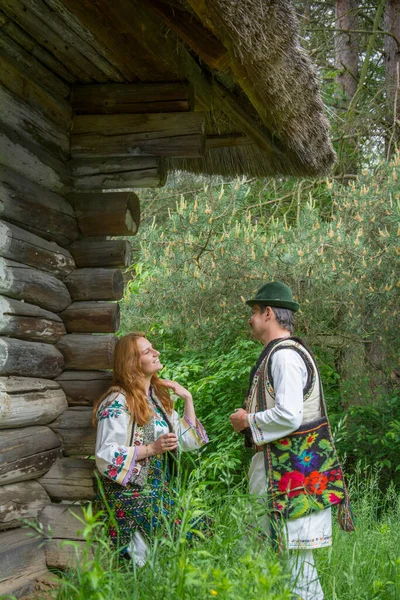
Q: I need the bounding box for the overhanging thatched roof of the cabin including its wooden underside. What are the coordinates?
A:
[0,0,334,176]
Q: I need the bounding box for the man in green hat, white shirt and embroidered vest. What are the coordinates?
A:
[230,281,332,600]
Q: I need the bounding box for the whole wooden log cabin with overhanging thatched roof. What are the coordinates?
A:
[0,0,334,597]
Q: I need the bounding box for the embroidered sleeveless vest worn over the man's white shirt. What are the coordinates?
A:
[246,338,321,425]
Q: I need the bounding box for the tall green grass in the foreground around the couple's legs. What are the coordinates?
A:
[50,469,400,600]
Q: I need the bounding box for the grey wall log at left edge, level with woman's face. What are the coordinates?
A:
[0,336,64,379]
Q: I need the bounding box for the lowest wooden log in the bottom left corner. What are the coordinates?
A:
[0,528,48,599]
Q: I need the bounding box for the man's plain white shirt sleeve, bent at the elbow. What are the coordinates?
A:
[248,348,307,446]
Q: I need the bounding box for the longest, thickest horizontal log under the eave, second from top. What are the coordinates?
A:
[71,112,205,158]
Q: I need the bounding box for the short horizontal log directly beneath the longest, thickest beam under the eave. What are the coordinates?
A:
[69,156,167,192]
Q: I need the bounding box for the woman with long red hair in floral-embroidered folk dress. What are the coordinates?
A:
[93,333,208,566]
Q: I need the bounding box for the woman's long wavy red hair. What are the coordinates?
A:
[92,333,172,425]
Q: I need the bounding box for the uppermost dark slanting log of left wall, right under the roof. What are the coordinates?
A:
[0,29,69,98]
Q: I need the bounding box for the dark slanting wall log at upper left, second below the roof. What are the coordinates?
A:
[0,55,72,129]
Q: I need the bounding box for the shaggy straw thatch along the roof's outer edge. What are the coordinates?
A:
[170,0,335,175]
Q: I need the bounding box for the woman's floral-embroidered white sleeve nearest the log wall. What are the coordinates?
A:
[95,394,141,486]
